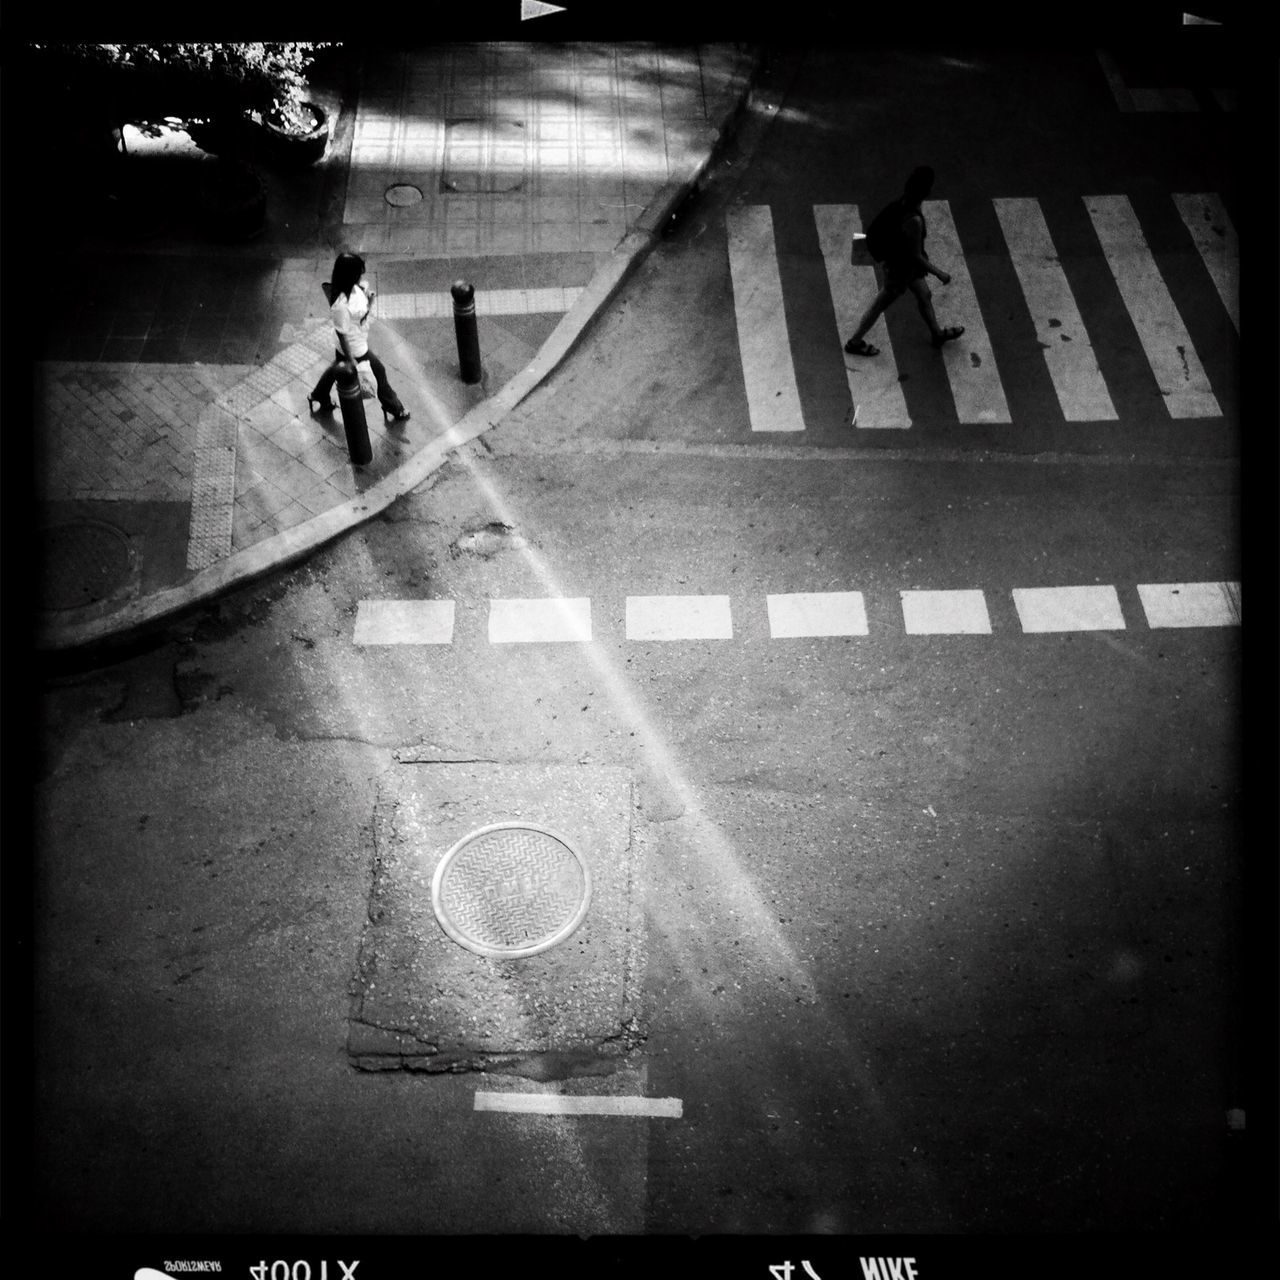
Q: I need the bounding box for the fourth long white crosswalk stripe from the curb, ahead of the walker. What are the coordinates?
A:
[995,198,1119,422]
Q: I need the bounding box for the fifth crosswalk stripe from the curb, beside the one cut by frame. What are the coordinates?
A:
[1084,196,1222,417]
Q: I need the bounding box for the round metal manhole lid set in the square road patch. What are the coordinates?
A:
[431,822,591,959]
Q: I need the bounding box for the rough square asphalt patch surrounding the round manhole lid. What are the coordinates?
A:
[347,763,643,1078]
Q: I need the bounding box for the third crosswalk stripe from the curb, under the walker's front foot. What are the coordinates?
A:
[924,200,1010,422]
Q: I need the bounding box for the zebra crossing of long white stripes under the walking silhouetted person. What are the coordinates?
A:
[726,192,1239,433]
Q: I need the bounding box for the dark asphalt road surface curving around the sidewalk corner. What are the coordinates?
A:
[24,32,1244,1261]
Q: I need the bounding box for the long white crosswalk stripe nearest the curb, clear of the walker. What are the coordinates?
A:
[726,205,804,431]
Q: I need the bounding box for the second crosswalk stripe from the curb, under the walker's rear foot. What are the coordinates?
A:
[813,205,911,429]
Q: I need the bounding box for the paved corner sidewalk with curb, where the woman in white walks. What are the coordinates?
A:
[35,44,755,650]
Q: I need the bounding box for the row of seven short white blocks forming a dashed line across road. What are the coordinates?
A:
[352,582,1240,648]
